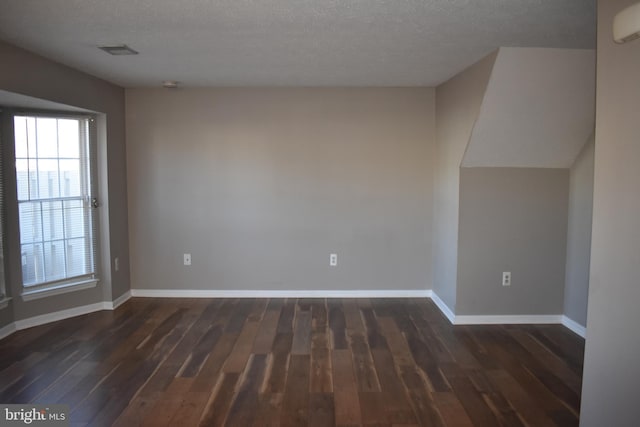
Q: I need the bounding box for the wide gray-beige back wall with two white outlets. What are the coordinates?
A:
[126,88,435,290]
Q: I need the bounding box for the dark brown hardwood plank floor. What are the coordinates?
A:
[0,298,584,427]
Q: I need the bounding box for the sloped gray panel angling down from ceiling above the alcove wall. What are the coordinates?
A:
[462,48,595,168]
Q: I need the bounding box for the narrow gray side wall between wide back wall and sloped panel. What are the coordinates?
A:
[433,51,498,310]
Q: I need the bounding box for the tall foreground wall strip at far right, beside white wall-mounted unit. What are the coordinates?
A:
[580,0,640,427]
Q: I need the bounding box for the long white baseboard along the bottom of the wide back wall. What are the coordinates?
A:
[131,289,432,298]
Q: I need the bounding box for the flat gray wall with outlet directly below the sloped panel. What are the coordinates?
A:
[456,168,569,315]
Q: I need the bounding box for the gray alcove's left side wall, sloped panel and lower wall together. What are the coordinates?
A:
[434,48,595,321]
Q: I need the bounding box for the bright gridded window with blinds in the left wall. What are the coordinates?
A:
[13,115,98,291]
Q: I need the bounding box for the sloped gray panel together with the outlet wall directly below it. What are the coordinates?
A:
[456,48,595,321]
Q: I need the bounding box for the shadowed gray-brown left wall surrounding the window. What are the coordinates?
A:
[0,42,129,320]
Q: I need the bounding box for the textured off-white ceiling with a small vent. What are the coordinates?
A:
[0,0,596,87]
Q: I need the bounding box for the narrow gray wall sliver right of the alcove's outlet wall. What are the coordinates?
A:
[564,136,594,326]
